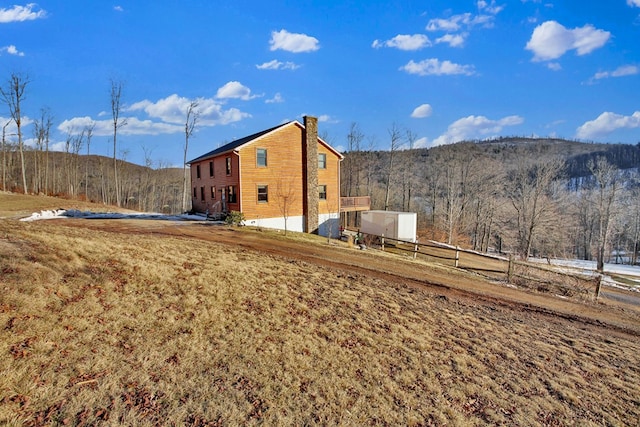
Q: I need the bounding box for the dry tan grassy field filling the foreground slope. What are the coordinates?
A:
[0,196,640,426]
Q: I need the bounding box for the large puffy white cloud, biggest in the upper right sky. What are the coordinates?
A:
[525,21,611,61]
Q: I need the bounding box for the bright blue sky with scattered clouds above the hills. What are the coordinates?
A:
[0,0,640,165]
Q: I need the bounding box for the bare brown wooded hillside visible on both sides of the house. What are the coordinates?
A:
[0,132,640,264]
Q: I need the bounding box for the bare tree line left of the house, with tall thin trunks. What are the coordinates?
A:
[0,73,190,213]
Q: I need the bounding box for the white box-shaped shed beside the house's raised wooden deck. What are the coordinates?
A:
[360,211,418,242]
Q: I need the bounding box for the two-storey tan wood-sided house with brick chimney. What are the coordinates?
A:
[189,116,343,235]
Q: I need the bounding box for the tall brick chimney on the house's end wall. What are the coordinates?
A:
[302,116,320,234]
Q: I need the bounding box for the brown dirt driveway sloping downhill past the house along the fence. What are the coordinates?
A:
[57,219,640,335]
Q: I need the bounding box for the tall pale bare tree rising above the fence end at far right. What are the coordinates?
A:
[587,157,619,273]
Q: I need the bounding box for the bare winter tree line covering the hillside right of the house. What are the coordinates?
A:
[341,124,640,269]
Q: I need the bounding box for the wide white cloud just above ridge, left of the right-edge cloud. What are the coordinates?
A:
[431,116,524,146]
